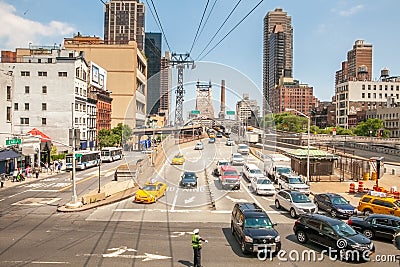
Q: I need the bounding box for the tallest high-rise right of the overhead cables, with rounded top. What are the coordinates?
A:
[263,8,293,111]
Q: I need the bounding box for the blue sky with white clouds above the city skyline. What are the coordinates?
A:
[0,0,400,105]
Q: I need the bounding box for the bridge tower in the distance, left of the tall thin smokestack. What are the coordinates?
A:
[196,82,215,119]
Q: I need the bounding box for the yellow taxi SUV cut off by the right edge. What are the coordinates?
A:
[357,194,400,216]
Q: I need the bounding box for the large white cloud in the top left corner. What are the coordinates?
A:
[0,1,76,50]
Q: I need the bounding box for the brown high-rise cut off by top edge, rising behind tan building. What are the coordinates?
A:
[104,0,145,50]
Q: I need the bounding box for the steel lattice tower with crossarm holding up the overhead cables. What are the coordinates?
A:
[169,53,195,125]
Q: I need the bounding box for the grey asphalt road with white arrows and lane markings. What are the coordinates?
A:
[0,142,400,267]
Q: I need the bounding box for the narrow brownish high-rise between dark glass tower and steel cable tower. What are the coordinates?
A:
[158,52,171,124]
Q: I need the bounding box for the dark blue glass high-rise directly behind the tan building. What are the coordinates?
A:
[144,32,161,114]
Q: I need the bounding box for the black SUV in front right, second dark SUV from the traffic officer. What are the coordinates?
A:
[293,214,375,261]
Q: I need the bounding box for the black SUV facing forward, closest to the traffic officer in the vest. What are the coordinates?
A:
[231,202,281,254]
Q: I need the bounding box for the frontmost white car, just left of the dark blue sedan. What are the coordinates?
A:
[275,189,318,218]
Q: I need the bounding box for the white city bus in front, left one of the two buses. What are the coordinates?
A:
[65,150,100,171]
